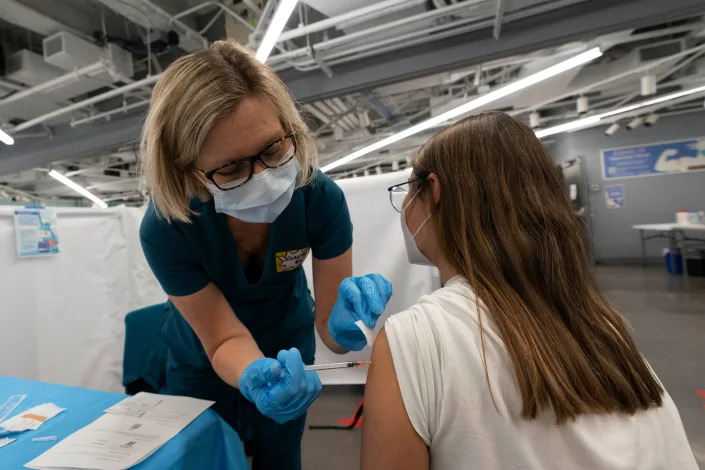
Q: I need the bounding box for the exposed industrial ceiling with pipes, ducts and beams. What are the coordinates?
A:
[0,0,705,204]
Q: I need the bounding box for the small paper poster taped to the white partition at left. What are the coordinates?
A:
[15,207,59,258]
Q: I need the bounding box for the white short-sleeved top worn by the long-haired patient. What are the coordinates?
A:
[385,276,698,470]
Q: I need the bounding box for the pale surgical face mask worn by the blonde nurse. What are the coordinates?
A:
[204,149,301,224]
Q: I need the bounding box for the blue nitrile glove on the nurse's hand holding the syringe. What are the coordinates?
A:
[238,348,321,424]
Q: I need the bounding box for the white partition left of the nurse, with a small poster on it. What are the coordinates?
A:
[0,207,165,391]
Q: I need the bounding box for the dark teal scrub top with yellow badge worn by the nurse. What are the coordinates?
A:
[140,171,352,368]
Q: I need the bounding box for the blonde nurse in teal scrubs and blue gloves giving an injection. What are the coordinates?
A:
[140,41,392,469]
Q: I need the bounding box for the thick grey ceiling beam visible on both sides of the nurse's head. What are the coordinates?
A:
[0,0,703,175]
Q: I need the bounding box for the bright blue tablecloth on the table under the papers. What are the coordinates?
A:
[0,376,249,470]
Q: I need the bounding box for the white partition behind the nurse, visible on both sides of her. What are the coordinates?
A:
[0,172,438,391]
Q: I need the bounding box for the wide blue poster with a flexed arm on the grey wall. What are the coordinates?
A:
[601,137,705,180]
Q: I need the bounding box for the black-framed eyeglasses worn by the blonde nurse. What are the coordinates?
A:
[194,132,296,191]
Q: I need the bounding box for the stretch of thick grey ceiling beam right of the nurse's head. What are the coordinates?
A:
[280,0,703,102]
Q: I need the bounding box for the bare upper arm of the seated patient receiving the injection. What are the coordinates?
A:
[361,328,429,470]
